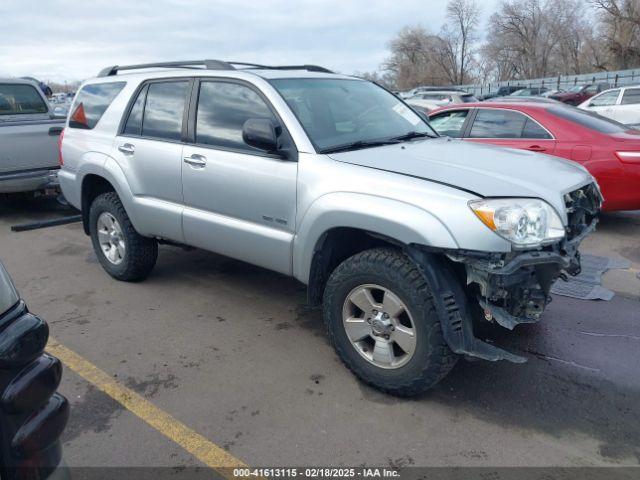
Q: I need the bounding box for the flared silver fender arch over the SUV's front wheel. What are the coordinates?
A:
[293,192,458,284]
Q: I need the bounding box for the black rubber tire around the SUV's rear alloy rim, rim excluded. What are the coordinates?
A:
[89,192,158,282]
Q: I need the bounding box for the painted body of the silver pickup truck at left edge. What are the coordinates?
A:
[0,79,65,193]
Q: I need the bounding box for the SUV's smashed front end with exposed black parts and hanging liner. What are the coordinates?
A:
[412,184,602,363]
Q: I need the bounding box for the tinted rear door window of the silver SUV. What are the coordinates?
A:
[141,80,189,140]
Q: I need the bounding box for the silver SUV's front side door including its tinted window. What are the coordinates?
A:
[182,79,298,274]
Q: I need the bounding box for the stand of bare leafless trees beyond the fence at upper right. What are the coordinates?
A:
[372,0,640,89]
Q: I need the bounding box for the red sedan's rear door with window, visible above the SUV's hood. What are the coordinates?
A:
[467,108,556,153]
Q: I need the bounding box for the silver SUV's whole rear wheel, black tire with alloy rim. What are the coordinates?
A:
[89,192,158,282]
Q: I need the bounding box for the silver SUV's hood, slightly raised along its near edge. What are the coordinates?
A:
[330,137,593,216]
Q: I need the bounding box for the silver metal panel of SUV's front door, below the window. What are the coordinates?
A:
[181,145,298,275]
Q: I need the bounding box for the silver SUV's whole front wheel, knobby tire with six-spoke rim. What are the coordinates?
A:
[324,248,458,396]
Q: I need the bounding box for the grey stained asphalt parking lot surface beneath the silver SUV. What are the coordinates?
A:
[0,195,640,468]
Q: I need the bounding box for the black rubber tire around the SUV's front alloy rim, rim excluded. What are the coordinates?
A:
[323,248,458,397]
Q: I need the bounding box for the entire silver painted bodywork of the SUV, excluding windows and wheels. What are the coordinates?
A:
[60,70,593,283]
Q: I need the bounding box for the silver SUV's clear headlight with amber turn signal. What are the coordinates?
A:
[469,198,565,248]
